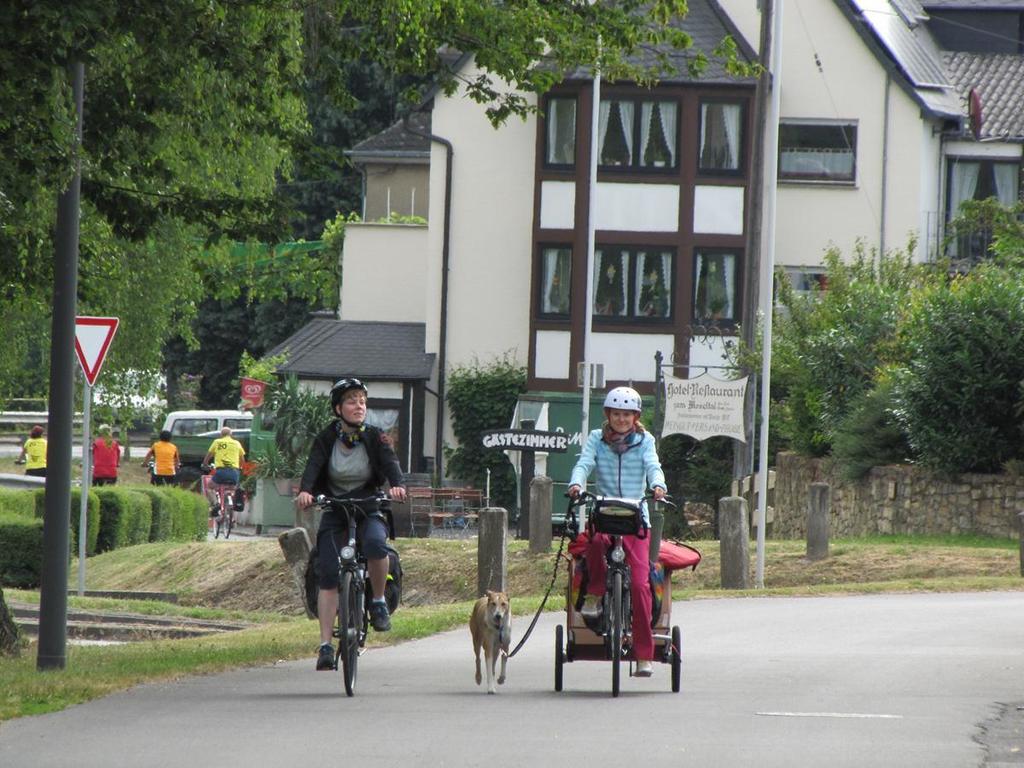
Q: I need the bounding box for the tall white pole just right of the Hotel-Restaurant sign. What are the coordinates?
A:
[755,0,782,589]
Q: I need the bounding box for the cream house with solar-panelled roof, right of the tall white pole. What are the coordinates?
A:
[722,0,1024,287]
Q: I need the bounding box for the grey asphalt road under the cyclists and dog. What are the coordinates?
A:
[0,593,1024,768]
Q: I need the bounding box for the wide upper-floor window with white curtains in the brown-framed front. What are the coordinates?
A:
[598,99,679,168]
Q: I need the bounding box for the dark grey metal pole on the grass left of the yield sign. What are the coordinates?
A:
[36,61,85,671]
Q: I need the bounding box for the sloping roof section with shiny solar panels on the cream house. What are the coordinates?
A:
[836,0,965,120]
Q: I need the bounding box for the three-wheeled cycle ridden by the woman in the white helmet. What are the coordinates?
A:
[555,492,700,696]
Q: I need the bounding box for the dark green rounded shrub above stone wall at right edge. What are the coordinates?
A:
[896,265,1024,473]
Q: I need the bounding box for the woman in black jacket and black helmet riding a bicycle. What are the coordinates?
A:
[295,378,406,670]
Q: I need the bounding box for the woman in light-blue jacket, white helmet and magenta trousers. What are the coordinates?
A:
[568,387,667,677]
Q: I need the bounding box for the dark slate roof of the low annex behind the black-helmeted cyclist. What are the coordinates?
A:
[267,317,434,381]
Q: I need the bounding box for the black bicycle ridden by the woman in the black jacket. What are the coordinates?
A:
[316,494,388,696]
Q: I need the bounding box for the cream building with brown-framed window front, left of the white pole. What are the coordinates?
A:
[331,0,755,481]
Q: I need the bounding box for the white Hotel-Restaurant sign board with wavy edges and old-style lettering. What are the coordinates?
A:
[662,374,748,442]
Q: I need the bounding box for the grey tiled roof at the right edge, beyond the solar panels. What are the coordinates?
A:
[943,51,1024,138]
